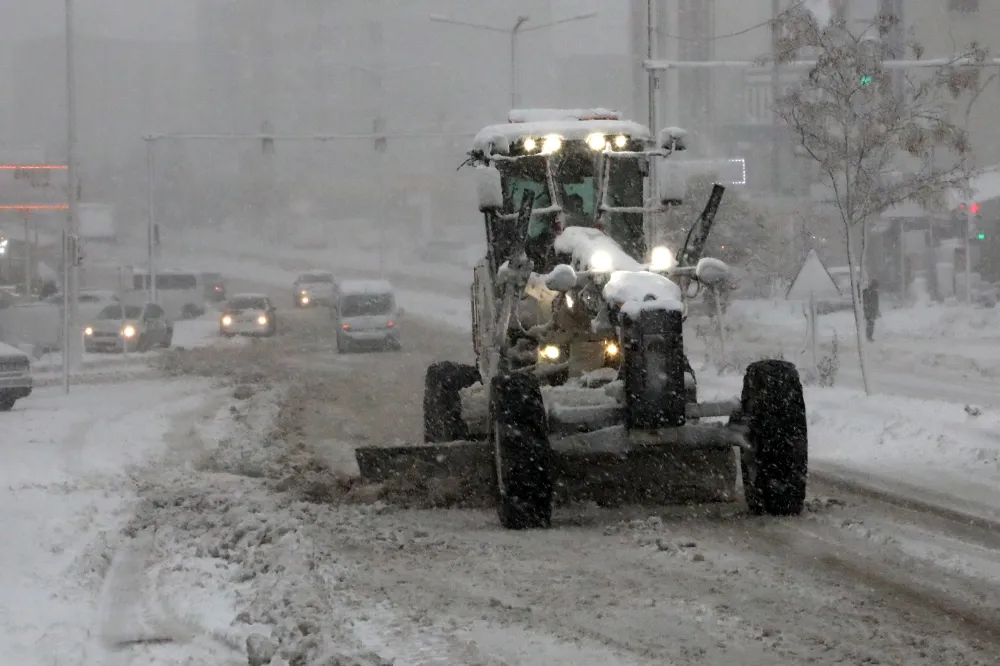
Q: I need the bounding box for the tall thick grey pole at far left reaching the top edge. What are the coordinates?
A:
[62,0,82,393]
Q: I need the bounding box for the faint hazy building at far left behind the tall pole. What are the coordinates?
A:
[8,34,197,223]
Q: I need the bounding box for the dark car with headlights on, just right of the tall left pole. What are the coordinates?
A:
[83,303,174,353]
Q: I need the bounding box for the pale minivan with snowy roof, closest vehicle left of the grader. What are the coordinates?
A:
[330,280,403,353]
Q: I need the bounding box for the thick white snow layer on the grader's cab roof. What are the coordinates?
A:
[473,109,653,151]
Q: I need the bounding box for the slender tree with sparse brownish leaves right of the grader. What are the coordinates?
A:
[772,4,987,394]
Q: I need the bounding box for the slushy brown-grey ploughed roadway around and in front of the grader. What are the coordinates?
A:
[113,300,1000,666]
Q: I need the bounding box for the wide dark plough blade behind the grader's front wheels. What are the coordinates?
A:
[355,428,737,507]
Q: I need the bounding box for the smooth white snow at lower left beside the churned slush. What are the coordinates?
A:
[0,380,229,666]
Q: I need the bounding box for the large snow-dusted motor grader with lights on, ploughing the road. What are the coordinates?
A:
[357,109,808,529]
